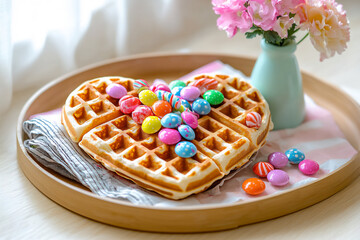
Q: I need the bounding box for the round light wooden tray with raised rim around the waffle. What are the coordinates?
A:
[17,54,360,232]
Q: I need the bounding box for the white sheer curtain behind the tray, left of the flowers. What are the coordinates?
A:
[0,0,216,113]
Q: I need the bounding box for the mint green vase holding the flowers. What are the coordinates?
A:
[251,39,305,130]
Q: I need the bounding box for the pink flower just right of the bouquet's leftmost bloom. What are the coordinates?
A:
[247,0,278,31]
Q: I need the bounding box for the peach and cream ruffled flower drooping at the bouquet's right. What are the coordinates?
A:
[302,0,350,61]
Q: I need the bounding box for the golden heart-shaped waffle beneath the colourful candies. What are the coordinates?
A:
[62,75,272,199]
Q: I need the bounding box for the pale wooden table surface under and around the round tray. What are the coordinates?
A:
[0,0,360,240]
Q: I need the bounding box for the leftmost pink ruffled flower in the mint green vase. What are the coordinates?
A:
[212,0,253,38]
